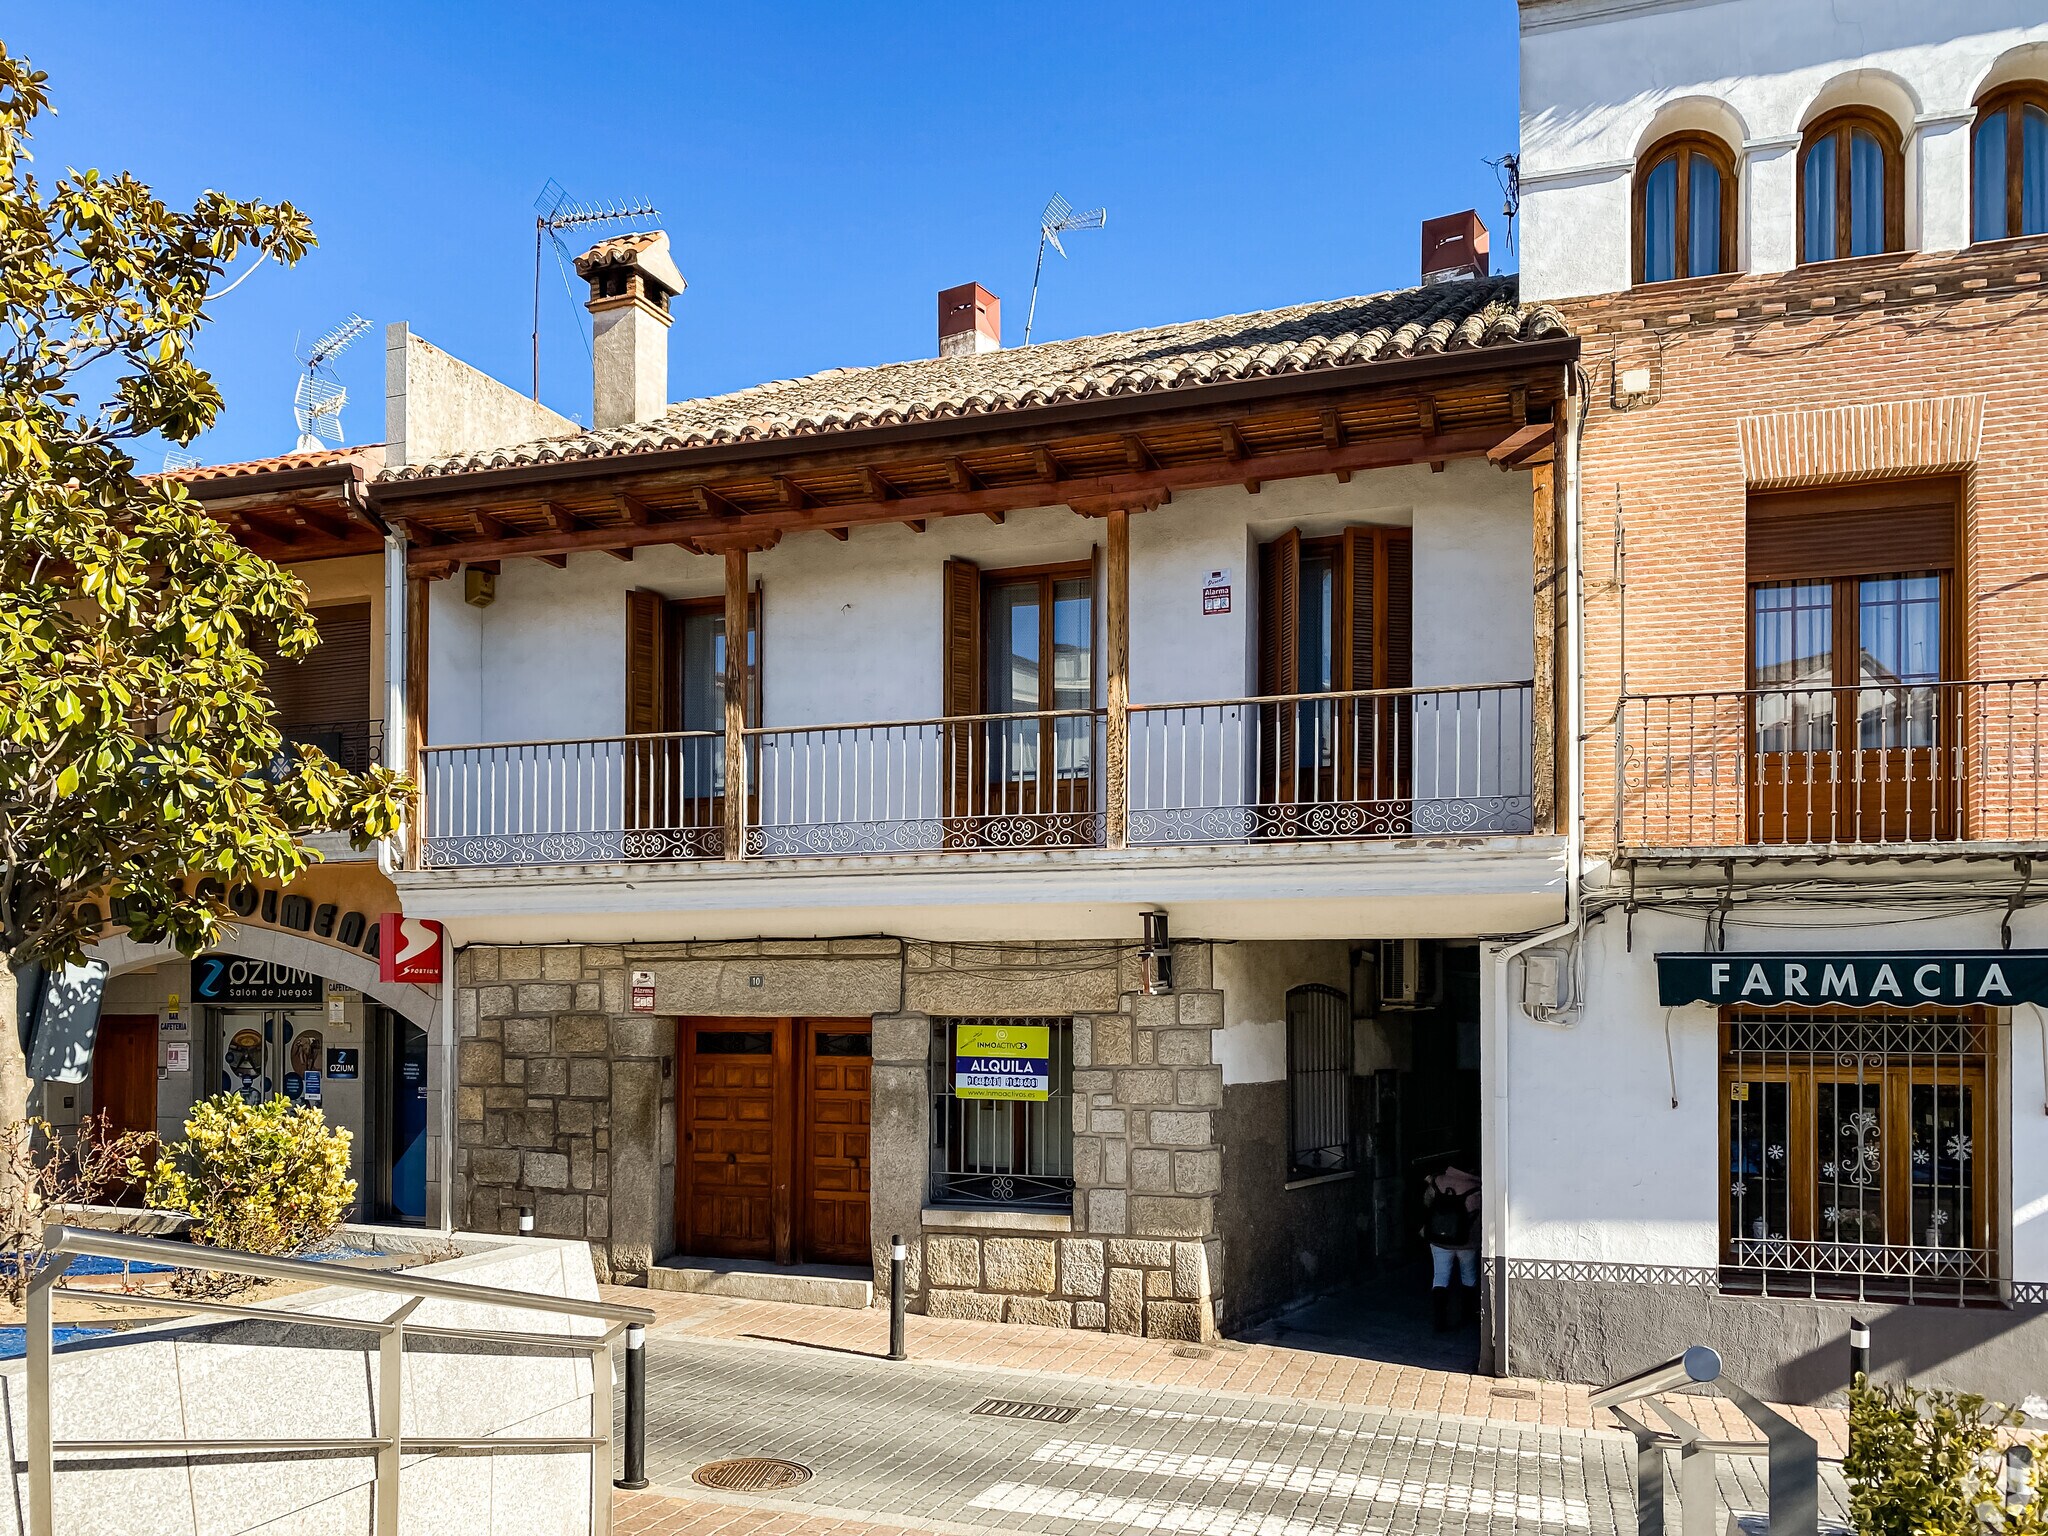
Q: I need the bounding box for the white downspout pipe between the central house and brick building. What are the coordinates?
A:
[1481,365,1587,1376]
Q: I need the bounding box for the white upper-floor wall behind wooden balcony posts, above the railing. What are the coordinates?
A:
[428,463,1534,743]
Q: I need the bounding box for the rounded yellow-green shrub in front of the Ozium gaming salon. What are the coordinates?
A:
[131,1094,356,1253]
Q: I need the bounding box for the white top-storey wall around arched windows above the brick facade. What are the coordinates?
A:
[1522,0,2048,299]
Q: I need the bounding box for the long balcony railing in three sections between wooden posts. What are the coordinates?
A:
[420,682,1532,868]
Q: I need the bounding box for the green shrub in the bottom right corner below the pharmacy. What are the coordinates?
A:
[1841,1376,2048,1536]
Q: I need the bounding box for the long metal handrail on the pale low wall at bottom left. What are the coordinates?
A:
[25,1225,653,1536]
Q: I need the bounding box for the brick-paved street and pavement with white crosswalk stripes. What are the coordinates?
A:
[598,1290,1841,1536]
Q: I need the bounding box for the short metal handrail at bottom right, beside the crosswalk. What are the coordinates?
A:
[1591,1343,1821,1536]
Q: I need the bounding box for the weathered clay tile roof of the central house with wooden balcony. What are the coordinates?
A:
[383,276,1569,479]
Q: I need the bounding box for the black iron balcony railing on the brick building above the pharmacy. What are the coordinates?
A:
[1614,678,2048,850]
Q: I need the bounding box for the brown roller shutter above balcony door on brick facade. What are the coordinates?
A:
[1747,479,1960,582]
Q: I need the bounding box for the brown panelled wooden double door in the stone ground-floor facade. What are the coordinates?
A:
[676,1018,874,1264]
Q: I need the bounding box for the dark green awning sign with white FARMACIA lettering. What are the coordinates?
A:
[1657,950,2048,1008]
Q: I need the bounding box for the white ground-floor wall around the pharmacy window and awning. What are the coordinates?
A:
[1490,903,2048,1280]
